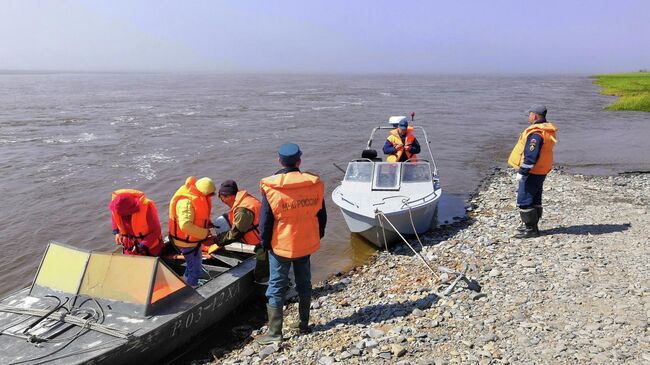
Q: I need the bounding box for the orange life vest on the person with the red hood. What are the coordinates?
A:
[111,189,163,256]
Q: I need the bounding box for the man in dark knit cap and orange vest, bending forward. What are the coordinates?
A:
[214,180,269,284]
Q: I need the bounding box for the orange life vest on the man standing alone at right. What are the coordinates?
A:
[508,122,557,175]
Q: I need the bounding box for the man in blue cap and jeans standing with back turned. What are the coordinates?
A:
[257,143,327,344]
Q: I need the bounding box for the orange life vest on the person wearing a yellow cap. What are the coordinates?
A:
[169,176,212,248]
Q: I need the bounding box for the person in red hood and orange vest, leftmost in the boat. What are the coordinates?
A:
[108,189,163,256]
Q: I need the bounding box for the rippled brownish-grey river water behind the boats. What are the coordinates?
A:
[0,73,650,294]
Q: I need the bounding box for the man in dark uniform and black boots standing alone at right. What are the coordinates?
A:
[508,105,557,238]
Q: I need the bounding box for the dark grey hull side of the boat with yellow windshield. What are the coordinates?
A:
[0,257,255,364]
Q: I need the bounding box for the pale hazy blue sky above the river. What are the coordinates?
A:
[0,0,650,73]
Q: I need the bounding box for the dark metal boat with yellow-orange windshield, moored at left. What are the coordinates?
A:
[0,242,255,364]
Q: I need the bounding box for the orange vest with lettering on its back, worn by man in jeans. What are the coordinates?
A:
[260,171,325,258]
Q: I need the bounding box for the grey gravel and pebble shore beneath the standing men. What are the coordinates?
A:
[214,170,650,365]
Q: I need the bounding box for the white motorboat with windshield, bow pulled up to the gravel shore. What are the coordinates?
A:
[332,117,442,248]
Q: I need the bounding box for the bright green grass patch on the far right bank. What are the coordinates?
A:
[594,72,650,112]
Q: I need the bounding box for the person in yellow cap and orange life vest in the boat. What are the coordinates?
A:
[169,176,216,286]
